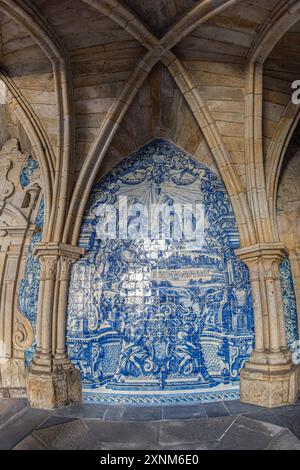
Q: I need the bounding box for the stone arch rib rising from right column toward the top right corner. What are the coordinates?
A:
[246,0,300,242]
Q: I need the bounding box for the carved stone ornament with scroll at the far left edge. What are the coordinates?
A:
[0,139,43,392]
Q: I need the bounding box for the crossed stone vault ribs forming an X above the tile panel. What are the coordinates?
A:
[64,0,256,245]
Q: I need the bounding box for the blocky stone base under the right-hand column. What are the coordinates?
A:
[241,362,299,408]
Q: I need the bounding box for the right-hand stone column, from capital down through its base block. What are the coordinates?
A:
[236,243,298,408]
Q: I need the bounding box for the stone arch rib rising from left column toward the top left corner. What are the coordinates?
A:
[0,0,74,241]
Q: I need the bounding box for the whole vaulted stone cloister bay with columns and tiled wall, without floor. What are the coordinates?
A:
[0,0,300,450]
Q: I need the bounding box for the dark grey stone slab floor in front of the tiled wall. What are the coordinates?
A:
[0,399,300,450]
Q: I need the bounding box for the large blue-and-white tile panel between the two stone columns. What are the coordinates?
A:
[67,139,254,404]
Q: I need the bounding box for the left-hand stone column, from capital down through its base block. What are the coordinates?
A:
[27,243,83,408]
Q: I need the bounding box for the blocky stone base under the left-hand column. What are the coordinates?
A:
[27,364,82,409]
